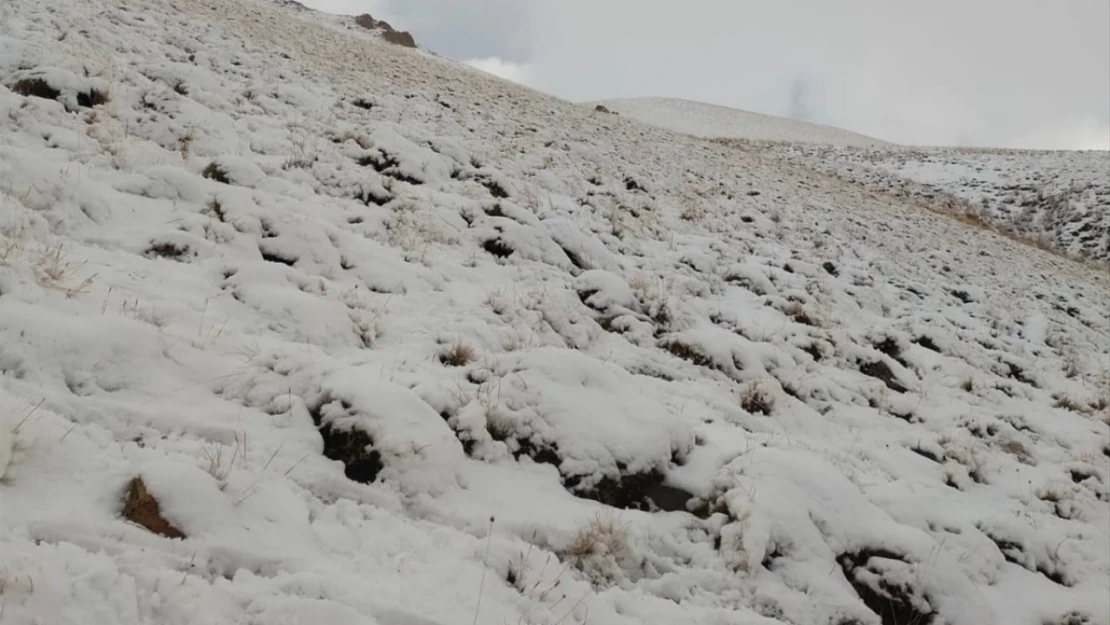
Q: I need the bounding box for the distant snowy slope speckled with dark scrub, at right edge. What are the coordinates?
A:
[754,143,1110,263]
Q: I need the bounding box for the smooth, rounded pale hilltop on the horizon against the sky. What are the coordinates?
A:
[588,98,888,148]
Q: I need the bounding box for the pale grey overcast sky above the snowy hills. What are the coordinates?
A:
[302,0,1110,150]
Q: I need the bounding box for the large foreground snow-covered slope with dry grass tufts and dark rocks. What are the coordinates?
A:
[0,0,1110,625]
